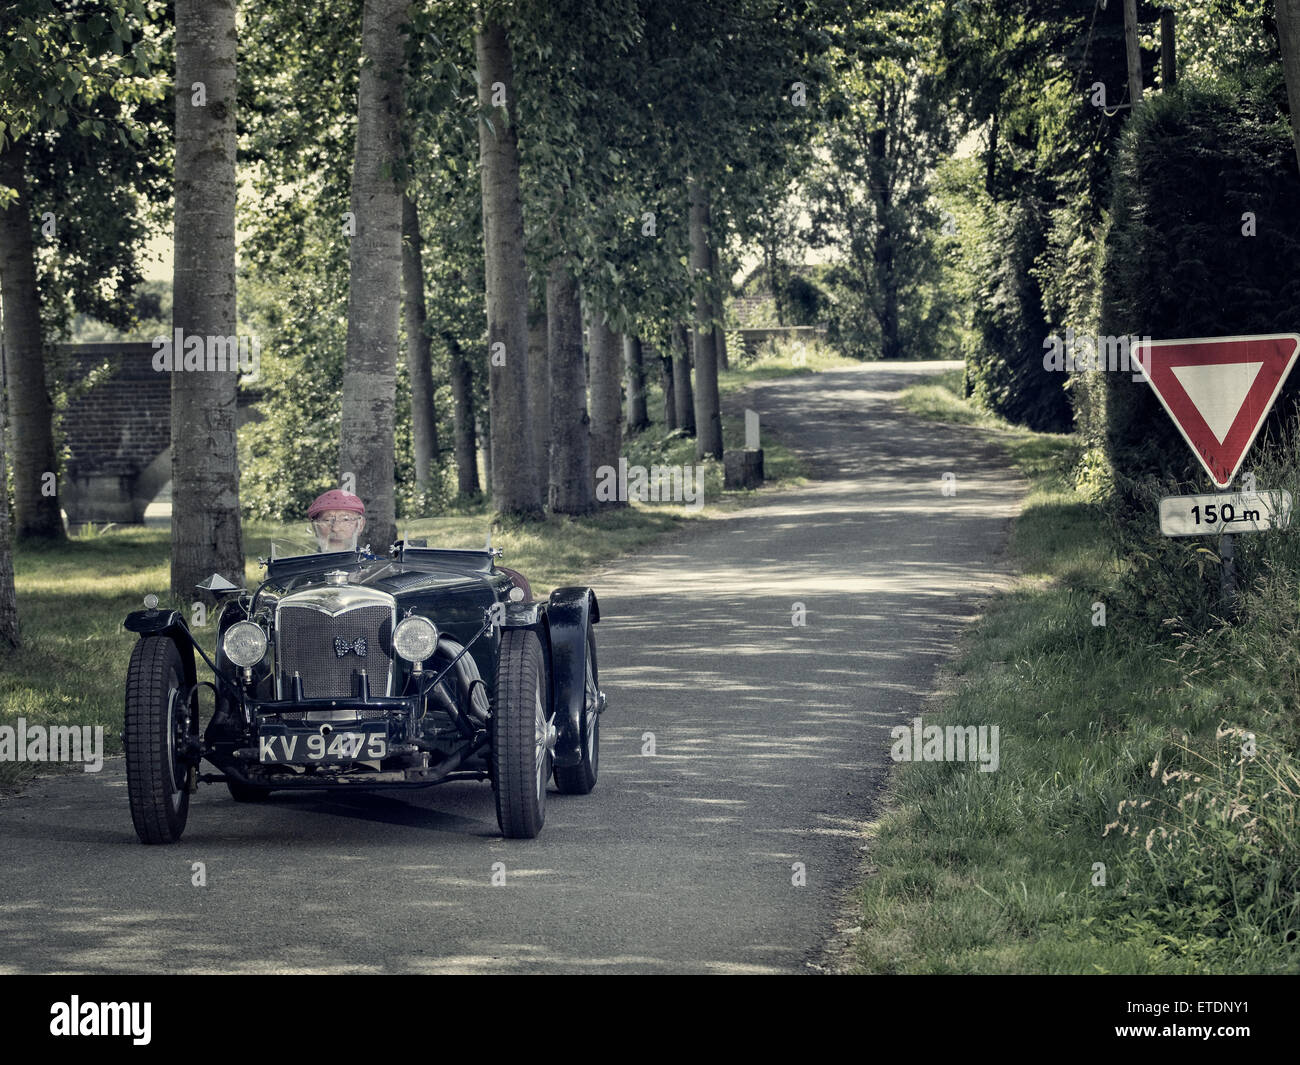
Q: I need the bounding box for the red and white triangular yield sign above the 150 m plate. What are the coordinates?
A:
[1138,333,1300,488]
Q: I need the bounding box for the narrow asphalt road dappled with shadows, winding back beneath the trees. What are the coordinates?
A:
[0,363,1023,973]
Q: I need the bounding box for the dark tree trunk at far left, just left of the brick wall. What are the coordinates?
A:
[0,142,64,541]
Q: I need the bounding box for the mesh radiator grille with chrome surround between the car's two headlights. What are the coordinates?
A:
[276,602,395,698]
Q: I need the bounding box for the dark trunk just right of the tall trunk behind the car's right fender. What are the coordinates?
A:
[546,259,594,514]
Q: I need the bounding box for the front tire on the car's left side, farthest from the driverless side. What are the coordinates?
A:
[124,636,198,844]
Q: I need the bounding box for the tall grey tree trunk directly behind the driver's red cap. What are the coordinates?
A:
[339,0,408,554]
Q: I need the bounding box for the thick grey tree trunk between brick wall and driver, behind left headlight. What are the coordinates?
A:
[172,0,244,602]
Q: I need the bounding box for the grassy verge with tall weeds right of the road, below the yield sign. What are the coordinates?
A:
[855,375,1300,973]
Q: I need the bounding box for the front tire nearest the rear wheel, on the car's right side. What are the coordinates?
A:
[491,629,551,840]
